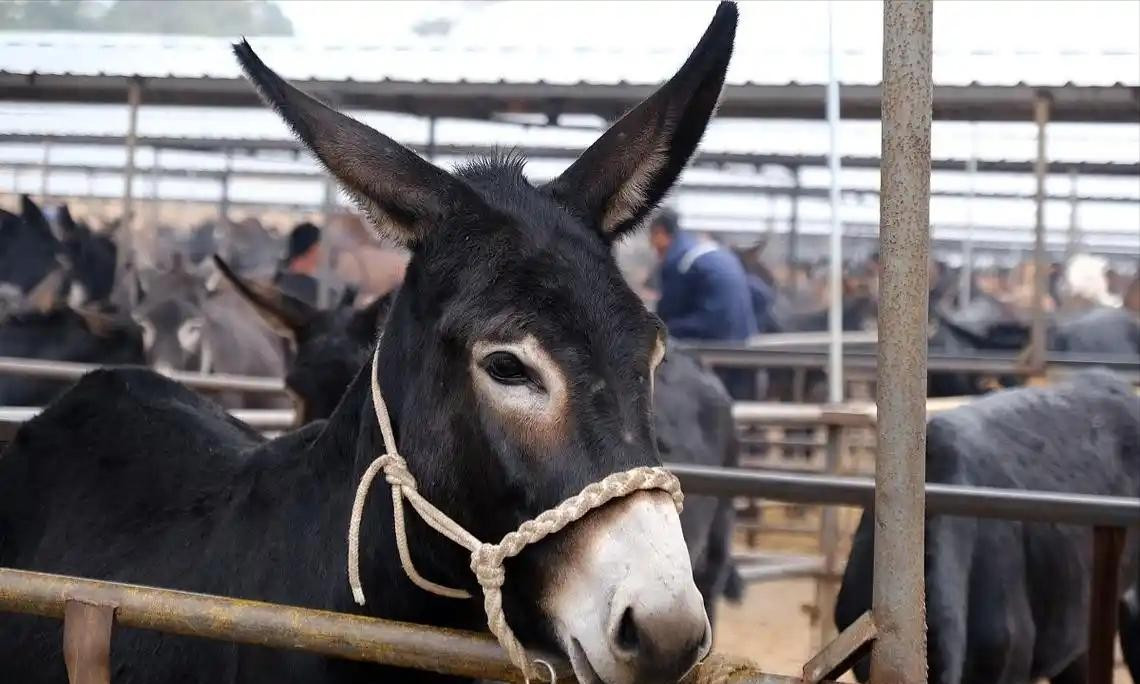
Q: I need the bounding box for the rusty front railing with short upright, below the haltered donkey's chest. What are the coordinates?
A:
[0,568,848,684]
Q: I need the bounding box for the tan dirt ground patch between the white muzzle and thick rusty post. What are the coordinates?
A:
[714,579,1140,684]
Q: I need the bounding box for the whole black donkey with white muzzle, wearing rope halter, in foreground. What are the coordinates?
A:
[0,3,736,684]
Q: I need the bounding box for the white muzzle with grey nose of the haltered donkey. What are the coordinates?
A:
[545,491,711,684]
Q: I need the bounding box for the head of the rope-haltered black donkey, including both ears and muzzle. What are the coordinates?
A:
[236,3,736,684]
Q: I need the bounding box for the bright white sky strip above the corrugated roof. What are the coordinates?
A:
[280,0,1140,52]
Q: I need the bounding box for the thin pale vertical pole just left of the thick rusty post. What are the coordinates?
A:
[828,2,844,404]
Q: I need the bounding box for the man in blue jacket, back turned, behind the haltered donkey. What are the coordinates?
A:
[650,209,757,399]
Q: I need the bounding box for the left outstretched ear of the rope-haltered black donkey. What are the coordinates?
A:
[234,41,480,245]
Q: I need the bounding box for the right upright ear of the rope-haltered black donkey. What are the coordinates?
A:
[548,2,736,238]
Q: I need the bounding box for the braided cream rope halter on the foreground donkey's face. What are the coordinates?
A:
[349,347,684,682]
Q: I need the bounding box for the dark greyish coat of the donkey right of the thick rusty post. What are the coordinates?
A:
[836,372,1140,684]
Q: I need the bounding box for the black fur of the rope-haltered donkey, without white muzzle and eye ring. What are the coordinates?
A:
[0,3,736,684]
